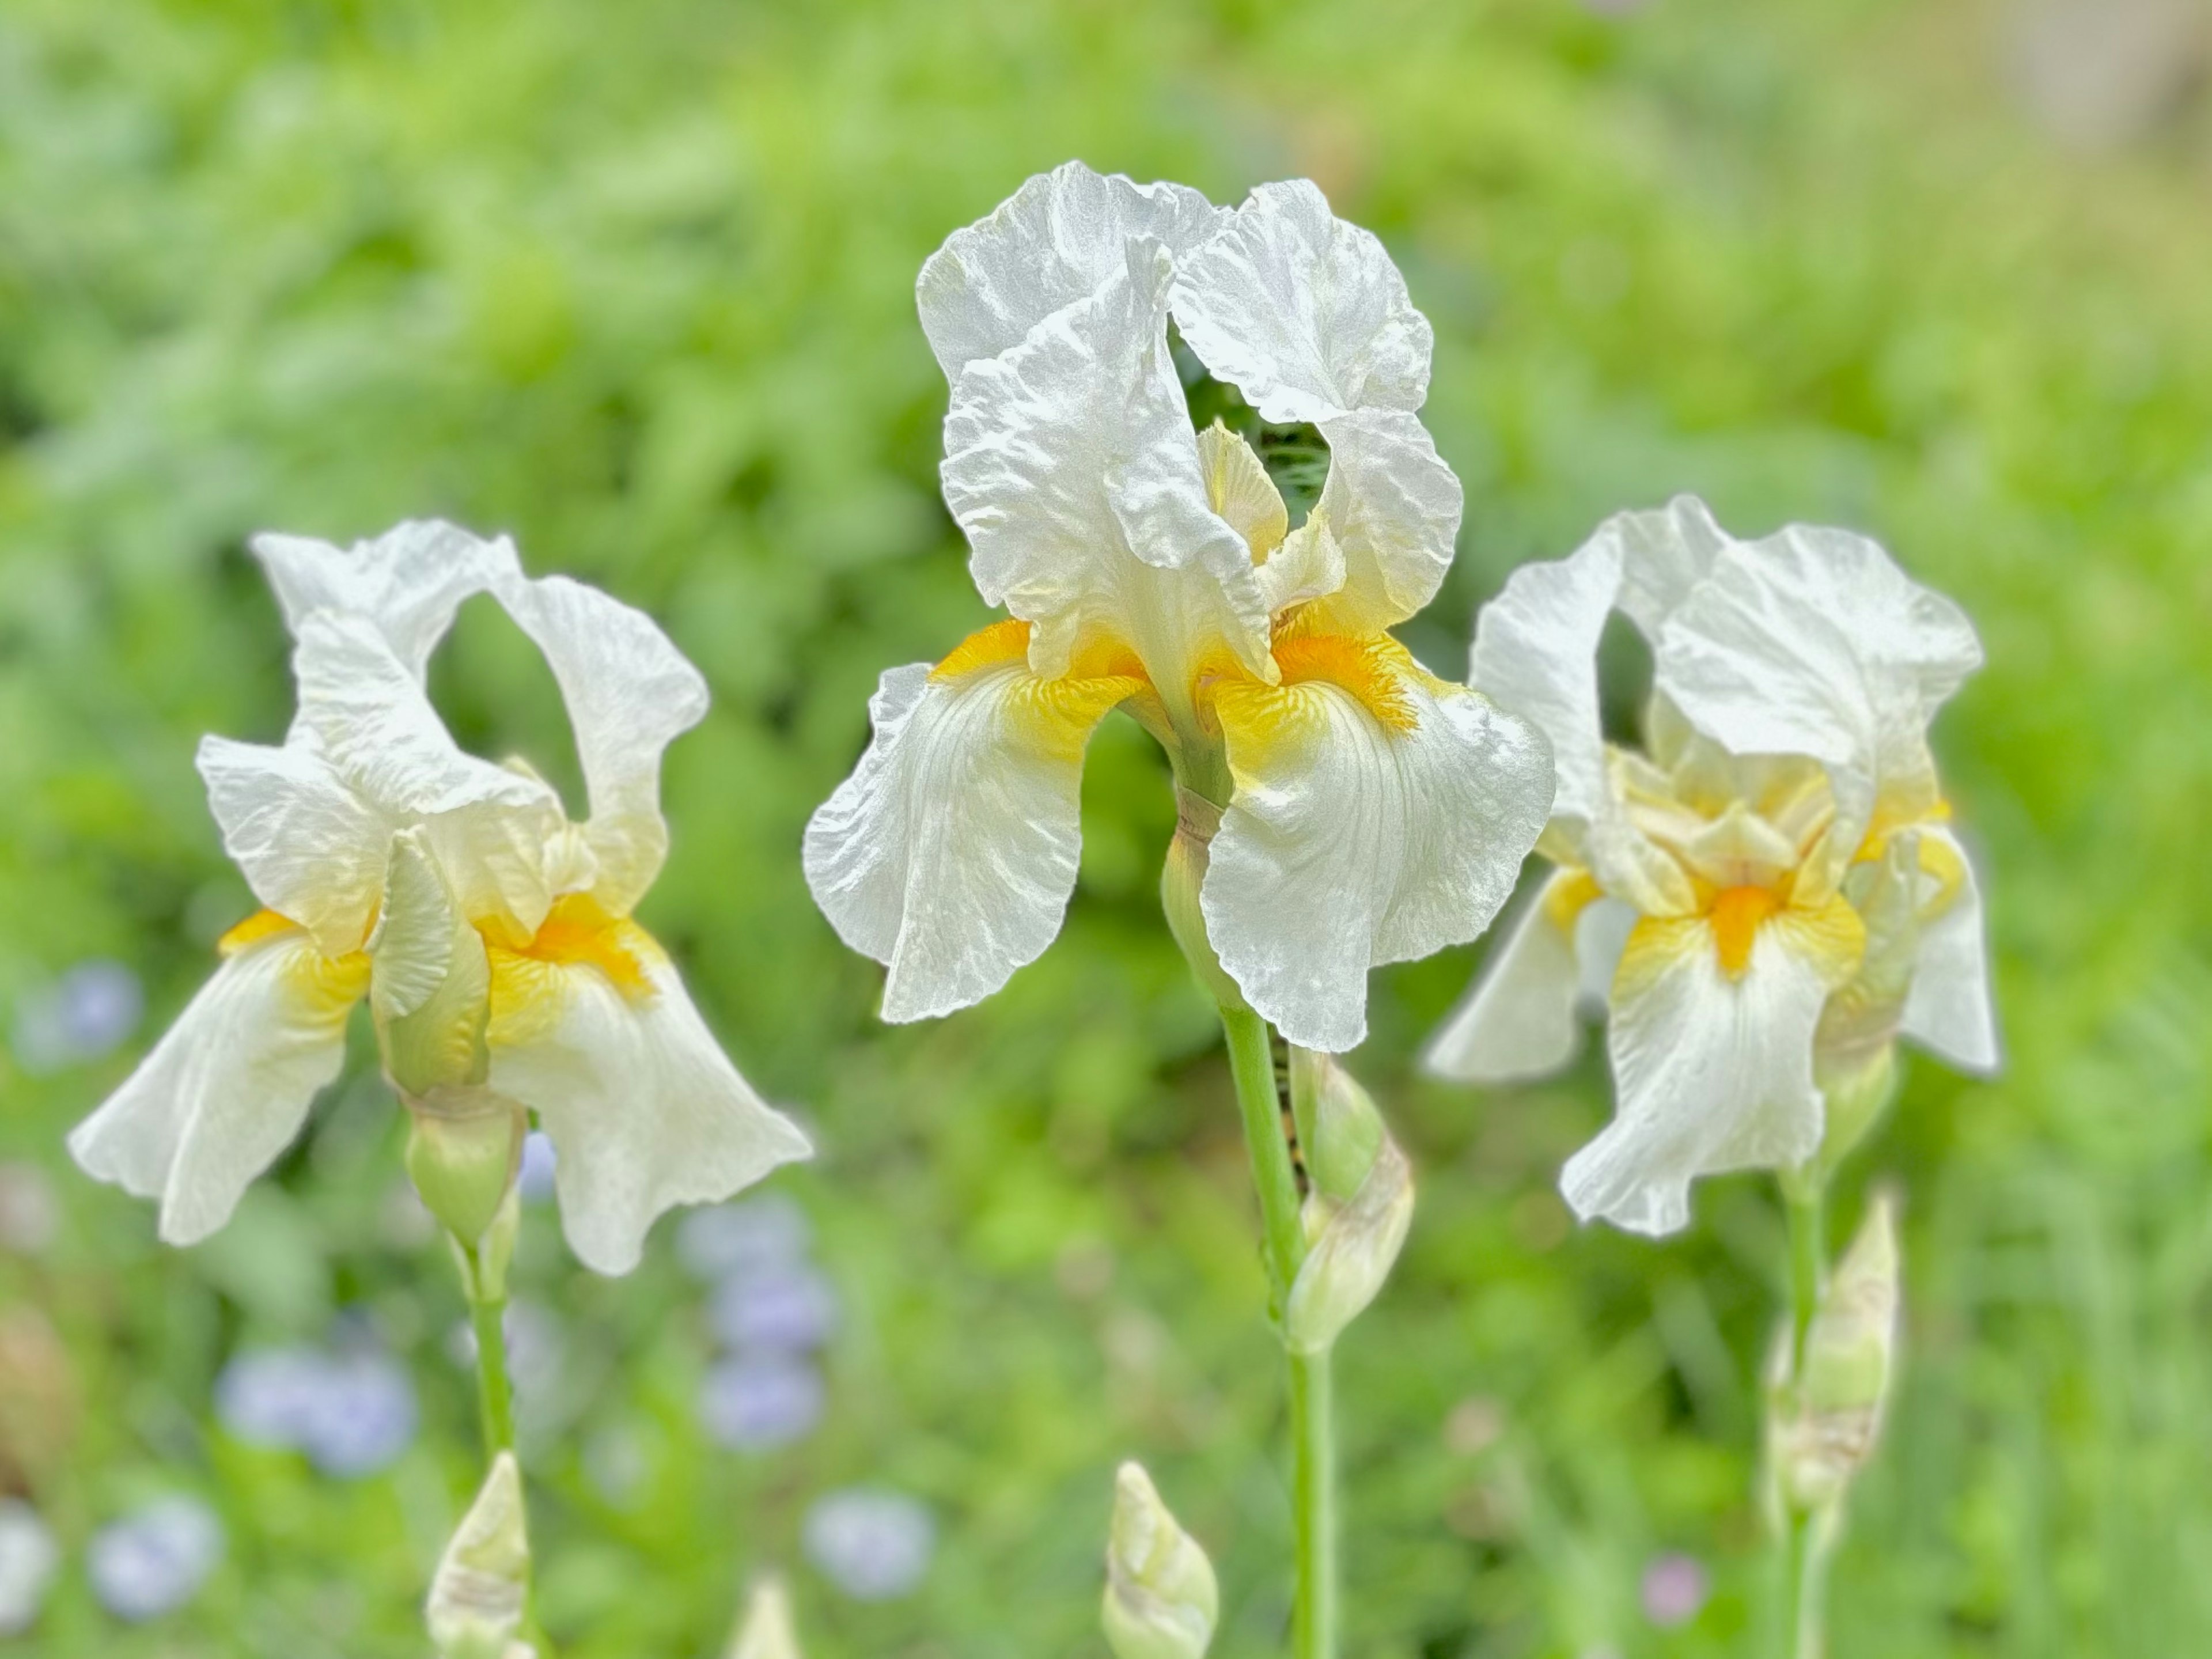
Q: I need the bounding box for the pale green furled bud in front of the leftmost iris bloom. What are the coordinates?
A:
[369,830,491,1097]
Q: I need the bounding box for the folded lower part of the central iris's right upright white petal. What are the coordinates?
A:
[1314,409,1467,635]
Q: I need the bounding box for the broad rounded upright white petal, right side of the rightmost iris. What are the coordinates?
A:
[1654,524,1982,902]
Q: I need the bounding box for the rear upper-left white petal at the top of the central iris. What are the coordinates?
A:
[914,161,1228,380]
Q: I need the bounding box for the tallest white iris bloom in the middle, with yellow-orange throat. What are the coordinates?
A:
[805,164,1551,1051]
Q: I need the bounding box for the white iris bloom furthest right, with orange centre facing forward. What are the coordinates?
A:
[1429,498,1998,1232]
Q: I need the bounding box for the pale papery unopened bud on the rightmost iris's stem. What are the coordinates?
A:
[1774,1192,1898,1513]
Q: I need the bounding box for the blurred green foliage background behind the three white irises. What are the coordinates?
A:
[0,0,2212,1659]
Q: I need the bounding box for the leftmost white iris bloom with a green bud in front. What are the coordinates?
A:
[71,524,808,1272]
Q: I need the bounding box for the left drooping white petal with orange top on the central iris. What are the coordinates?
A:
[805,622,1143,1020]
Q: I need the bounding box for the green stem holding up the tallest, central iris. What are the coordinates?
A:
[1221,1006,1336,1659]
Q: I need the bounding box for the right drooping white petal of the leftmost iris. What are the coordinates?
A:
[491,935,814,1274]
